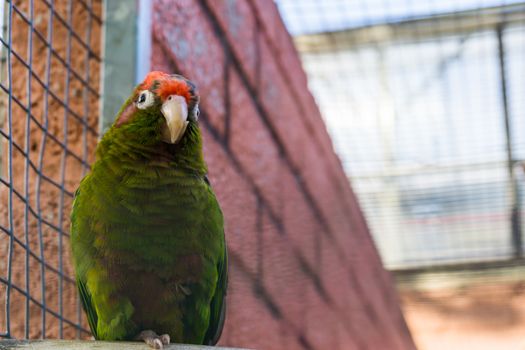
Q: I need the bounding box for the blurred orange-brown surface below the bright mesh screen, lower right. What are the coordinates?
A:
[399,270,525,350]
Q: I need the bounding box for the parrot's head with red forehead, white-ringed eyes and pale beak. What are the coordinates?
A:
[114,71,199,144]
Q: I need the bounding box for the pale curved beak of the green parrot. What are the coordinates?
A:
[160,95,188,143]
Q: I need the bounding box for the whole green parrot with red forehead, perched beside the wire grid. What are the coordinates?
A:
[71,72,228,349]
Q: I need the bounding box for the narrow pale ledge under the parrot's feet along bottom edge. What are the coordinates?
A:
[0,339,248,350]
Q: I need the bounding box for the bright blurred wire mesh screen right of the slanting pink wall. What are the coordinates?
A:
[277,0,525,269]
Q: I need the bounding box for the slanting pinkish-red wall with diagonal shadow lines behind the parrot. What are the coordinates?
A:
[152,0,414,350]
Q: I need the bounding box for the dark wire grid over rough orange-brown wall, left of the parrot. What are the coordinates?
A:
[0,0,102,338]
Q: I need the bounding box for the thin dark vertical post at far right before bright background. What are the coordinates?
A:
[496,24,523,259]
